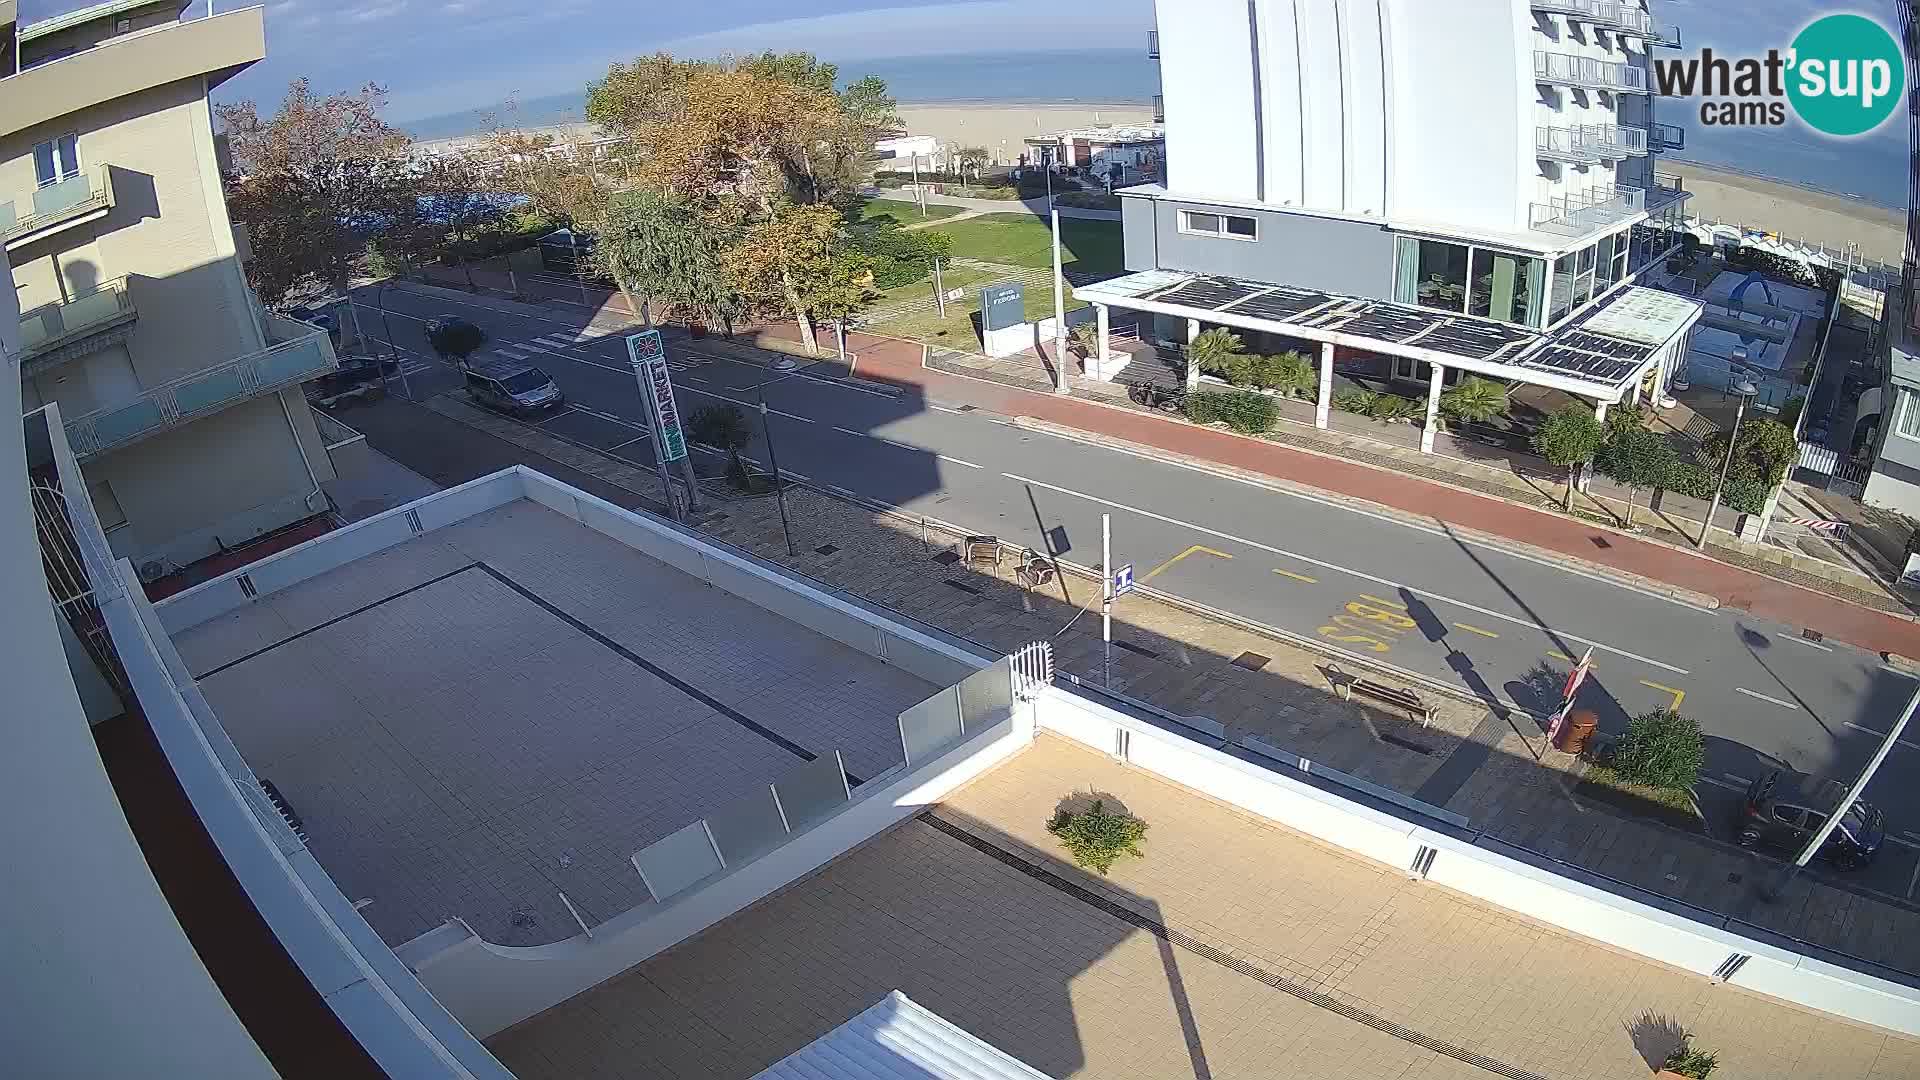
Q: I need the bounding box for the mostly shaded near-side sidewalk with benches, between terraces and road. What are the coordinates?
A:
[345,388,1920,972]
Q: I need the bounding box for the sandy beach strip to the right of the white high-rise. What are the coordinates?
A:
[1659,161,1907,265]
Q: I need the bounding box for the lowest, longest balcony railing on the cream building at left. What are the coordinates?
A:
[65,332,340,459]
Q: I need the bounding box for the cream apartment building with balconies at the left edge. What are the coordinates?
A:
[0,0,336,578]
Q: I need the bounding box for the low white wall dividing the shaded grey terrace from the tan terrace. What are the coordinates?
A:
[399,705,1033,1038]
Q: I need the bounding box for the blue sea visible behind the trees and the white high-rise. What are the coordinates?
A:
[401,50,1908,211]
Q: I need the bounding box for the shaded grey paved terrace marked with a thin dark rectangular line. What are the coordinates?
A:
[177,500,935,945]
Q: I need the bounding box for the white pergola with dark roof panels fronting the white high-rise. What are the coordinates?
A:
[1073,269,1703,454]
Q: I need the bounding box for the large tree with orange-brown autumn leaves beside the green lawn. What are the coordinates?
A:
[588,52,899,350]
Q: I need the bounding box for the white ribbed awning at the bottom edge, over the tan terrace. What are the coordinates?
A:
[755,990,1048,1080]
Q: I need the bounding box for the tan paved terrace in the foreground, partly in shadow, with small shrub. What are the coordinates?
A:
[490,736,1920,1080]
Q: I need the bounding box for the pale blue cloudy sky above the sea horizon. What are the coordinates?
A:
[19,0,1893,123]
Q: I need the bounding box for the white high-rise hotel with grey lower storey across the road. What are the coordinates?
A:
[1077,0,1699,447]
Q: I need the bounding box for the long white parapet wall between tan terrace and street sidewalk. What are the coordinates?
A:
[1035,686,1920,1036]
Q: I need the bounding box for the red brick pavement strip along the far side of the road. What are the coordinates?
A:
[733,325,1920,655]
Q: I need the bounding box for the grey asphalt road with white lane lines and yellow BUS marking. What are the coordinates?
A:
[361,290,1920,896]
